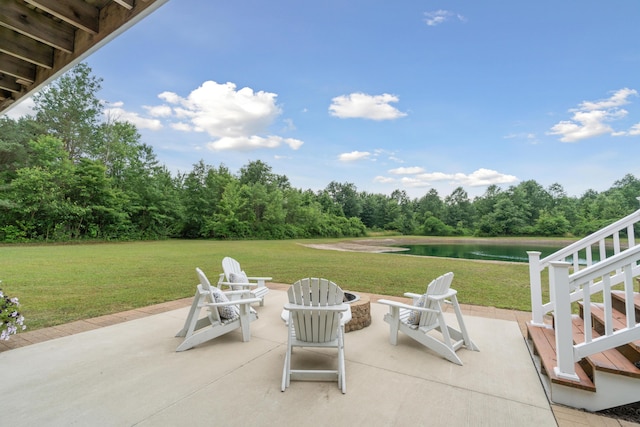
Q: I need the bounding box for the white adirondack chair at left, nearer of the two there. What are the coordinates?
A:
[176,268,260,351]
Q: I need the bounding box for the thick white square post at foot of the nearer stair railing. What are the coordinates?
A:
[549,261,580,381]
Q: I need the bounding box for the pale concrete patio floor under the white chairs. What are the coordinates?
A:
[0,284,633,427]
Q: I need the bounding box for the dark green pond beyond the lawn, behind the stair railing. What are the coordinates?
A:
[382,243,612,263]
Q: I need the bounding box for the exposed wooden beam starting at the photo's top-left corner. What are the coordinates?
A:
[0,0,75,53]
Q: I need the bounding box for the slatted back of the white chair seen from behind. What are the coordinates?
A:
[287,278,344,343]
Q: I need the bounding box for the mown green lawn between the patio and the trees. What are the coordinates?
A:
[0,239,544,330]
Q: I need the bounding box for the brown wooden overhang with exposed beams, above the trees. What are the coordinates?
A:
[0,0,168,115]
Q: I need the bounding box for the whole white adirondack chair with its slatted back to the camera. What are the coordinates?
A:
[282,278,349,393]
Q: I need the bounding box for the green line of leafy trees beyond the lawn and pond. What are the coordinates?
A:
[0,63,640,242]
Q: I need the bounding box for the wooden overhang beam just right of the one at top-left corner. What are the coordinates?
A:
[24,0,100,34]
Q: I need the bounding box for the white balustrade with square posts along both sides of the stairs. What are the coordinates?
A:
[528,204,640,379]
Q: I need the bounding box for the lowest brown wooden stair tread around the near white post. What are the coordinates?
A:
[527,322,596,392]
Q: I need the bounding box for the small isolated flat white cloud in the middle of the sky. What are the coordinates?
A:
[329,93,407,120]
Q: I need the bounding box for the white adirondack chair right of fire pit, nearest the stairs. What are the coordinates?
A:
[378,272,479,365]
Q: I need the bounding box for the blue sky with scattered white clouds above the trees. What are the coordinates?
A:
[5,0,640,198]
